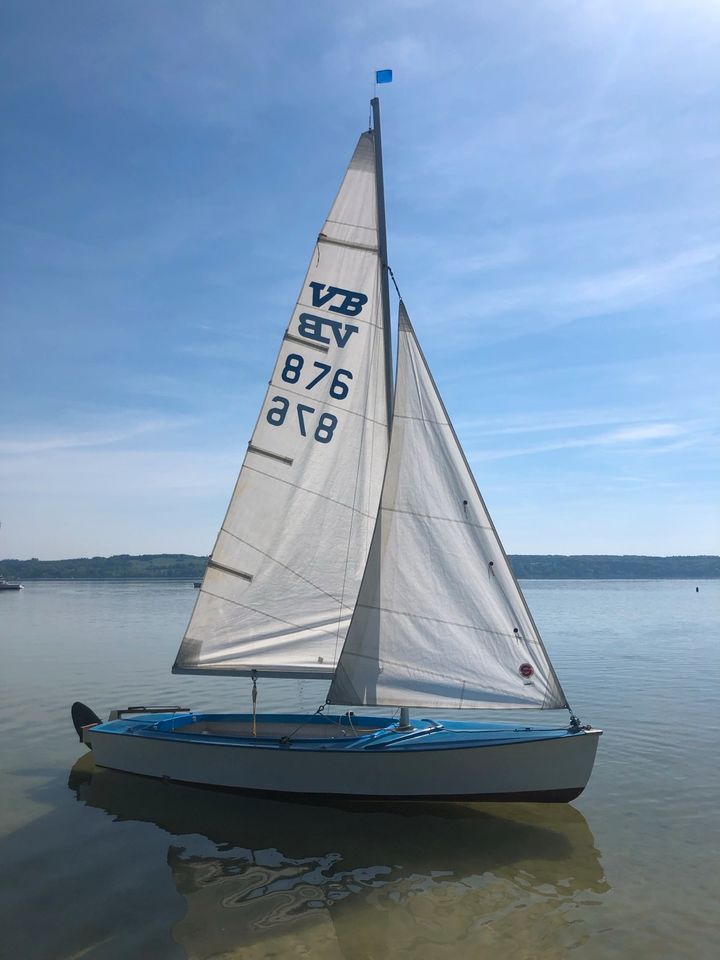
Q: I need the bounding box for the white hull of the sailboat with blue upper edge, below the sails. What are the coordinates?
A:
[85,712,600,802]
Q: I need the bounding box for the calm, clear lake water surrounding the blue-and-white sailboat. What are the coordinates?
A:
[0,581,720,960]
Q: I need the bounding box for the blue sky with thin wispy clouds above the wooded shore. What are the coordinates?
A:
[0,0,720,559]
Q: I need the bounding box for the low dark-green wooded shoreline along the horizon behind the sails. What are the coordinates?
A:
[0,553,720,580]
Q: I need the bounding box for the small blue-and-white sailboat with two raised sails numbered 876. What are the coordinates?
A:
[73,97,601,802]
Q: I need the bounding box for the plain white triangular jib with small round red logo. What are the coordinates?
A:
[328,303,566,708]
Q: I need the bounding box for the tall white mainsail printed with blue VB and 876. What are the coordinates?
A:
[173,132,388,677]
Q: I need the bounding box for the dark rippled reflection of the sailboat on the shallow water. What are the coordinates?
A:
[69,754,609,960]
